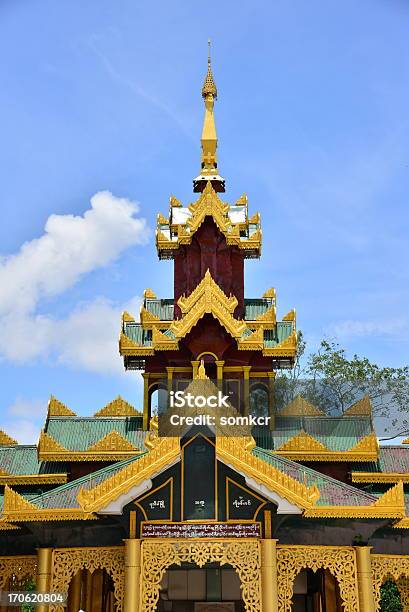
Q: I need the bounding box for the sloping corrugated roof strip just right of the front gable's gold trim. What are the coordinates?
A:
[252,447,377,506]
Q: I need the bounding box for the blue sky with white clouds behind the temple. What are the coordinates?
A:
[0,0,409,442]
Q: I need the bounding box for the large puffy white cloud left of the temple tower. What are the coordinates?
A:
[0,191,149,373]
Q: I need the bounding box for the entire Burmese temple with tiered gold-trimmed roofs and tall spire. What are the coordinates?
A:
[0,51,409,612]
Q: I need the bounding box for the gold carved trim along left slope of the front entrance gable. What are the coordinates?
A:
[77,438,180,512]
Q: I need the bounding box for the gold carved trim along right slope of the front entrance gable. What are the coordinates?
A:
[216,437,320,509]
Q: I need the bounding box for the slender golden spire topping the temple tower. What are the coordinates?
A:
[193,40,224,192]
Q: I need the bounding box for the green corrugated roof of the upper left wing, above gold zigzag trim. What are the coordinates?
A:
[46,417,146,452]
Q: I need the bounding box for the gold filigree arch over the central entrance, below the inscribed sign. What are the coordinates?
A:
[141,540,262,612]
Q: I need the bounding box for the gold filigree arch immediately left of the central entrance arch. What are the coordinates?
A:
[50,546,125,612]
